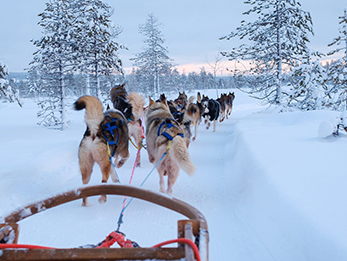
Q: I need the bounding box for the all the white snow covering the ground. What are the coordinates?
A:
[0,90,347,261]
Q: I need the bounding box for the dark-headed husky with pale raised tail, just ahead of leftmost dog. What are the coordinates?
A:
[110,83,145,167]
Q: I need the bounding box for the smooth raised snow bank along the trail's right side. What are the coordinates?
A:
[230,107,347,260]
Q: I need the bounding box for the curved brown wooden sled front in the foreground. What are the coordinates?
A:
[0,185,209,261]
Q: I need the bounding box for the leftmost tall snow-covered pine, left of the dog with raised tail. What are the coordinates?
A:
[29,0,77,130]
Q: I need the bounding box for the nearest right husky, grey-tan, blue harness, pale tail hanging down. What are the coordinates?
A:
[145,97,195,195]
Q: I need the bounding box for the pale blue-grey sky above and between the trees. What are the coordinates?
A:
[0,0,347,74]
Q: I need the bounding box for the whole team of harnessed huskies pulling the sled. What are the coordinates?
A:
[74,84,235,206]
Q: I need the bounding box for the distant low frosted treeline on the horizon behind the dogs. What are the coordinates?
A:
[6,68,234,100]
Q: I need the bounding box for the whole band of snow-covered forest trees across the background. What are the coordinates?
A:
[0,0,347,129]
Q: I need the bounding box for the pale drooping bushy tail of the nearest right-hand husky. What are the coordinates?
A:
[168,136,196,176]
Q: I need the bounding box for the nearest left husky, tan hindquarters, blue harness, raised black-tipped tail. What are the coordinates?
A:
[74,96,129,206]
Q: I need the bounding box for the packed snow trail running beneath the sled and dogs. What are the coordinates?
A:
[14,90,272,261]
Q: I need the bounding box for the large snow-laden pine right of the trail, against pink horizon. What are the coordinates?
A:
[220,0,313,104]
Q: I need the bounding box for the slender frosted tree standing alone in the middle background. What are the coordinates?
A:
[131,14,173,97]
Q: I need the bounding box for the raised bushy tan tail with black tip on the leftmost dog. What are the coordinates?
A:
[74,95,104,135]
